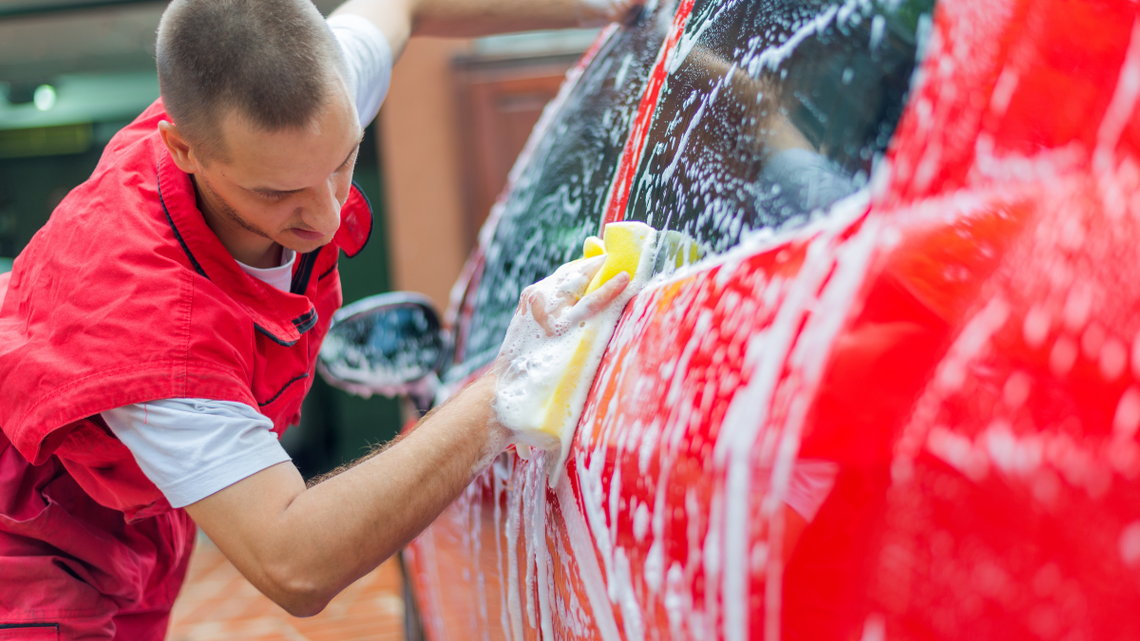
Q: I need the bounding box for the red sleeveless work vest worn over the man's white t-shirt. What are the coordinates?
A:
[0,100,372,518]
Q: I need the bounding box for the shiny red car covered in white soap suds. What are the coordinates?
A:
[324,0,1140,641]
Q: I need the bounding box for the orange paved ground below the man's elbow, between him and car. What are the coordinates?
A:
[166,537,404,641]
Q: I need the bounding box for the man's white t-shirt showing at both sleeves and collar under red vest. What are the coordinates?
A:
[103,15,392,508]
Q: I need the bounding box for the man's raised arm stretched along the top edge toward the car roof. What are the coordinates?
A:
[333,0,641,58]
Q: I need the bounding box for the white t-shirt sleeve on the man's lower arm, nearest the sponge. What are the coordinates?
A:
[103,398,291,508]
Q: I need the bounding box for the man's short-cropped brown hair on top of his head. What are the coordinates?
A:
[156,0,344,160]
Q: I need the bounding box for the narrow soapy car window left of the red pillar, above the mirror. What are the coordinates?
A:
[457,2,673,375]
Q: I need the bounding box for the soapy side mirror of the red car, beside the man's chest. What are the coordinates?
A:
[317,292,450,405]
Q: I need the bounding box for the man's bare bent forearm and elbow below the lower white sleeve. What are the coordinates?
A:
[186,375,502,616]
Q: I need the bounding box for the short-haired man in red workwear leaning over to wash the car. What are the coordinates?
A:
[0,0,628,641]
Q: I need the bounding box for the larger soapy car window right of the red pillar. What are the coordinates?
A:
[626,0,934,251]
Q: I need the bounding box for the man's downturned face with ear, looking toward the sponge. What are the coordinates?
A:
[195,83,363,262]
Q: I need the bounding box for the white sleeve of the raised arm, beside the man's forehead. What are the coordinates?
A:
[327,14,392,127]
